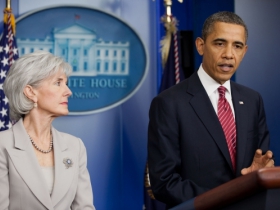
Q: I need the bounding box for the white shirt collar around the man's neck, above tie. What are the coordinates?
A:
[197,64,231,96]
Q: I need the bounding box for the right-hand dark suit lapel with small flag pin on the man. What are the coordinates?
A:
[231,83,248,175]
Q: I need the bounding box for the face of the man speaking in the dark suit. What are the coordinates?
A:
[196,22,247,84]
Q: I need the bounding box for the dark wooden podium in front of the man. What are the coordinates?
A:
[172,167,280,210]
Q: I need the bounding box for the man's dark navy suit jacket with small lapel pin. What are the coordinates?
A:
[148,72,269,207]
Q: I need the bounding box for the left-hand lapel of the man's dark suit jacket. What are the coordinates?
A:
[187,73,233,170]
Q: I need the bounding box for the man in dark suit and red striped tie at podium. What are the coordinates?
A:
[148,12,274,208]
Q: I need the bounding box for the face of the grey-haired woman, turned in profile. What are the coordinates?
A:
[35,71,72,117]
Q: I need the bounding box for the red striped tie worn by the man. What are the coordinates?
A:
[218,86,236,170]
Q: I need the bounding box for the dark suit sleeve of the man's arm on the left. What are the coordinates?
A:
[148,97,208,207]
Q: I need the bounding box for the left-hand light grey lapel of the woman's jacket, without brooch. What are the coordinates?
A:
[7,119,53,210]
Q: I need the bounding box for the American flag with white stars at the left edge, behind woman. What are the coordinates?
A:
[0,8,18,131]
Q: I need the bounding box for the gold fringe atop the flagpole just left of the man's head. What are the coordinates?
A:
[160,16,178,68]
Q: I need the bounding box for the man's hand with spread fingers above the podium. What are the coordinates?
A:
[241,149,274,175]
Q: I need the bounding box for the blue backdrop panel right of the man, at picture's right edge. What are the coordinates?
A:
[235,0,280,165]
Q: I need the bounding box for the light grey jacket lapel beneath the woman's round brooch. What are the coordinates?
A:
[51,128,75,206]
